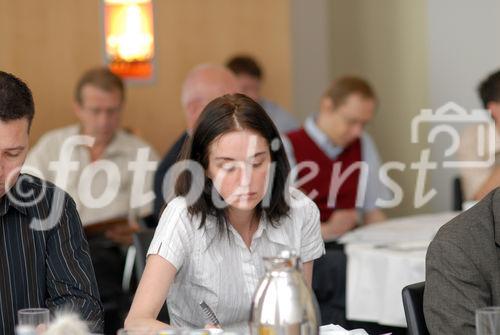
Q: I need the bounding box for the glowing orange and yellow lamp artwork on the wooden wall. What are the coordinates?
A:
[104,0,154,80]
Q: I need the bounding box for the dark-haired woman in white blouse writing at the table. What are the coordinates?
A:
[126,94,324,331]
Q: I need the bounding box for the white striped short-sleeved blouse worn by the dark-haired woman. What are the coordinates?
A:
[148,189,325,330]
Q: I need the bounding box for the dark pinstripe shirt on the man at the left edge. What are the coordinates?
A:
[0,174,103,335]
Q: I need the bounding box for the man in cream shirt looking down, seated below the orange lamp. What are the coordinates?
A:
[26,68,158,333]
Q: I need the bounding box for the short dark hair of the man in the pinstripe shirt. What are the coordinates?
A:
[0,71,35,129]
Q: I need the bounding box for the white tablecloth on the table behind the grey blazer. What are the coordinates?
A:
[340,212,458,327]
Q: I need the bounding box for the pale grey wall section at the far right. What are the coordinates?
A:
[427,0,500,211]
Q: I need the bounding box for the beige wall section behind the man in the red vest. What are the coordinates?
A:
[329,0,431,216]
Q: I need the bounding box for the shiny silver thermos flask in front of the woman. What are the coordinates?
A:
[250,250,321,335]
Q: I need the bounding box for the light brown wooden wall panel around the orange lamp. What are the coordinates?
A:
[0,0,292,153]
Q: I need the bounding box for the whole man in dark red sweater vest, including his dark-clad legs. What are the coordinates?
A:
[283,77,388,326]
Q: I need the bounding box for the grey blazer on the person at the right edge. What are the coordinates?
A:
[424,188,500,335]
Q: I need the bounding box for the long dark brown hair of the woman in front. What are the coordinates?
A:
[175,94,290,233]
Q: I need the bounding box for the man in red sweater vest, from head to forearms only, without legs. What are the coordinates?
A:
[287,77,386,240]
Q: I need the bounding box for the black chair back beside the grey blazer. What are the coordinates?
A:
[402,282,429,335]
